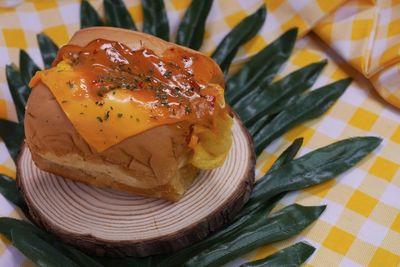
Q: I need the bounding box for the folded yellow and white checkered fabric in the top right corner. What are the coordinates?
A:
[314,0,400,108]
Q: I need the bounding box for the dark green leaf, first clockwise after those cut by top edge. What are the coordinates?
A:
[211,5,267,72]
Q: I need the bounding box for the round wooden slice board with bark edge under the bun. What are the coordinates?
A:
[17,119,255,256]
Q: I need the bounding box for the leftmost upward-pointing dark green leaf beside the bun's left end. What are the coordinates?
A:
[6,65,31,122]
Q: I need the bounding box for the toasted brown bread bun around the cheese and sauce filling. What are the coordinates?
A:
[25,27,224,201]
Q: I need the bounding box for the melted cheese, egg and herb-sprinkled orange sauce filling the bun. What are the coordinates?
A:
[30,39,232,169]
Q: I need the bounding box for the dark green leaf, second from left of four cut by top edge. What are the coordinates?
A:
[103,0,137,31]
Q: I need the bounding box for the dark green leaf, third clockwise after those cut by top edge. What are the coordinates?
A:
[234,61,326,126]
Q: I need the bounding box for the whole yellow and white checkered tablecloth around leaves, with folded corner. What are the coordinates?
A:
[0,0,400,267]
